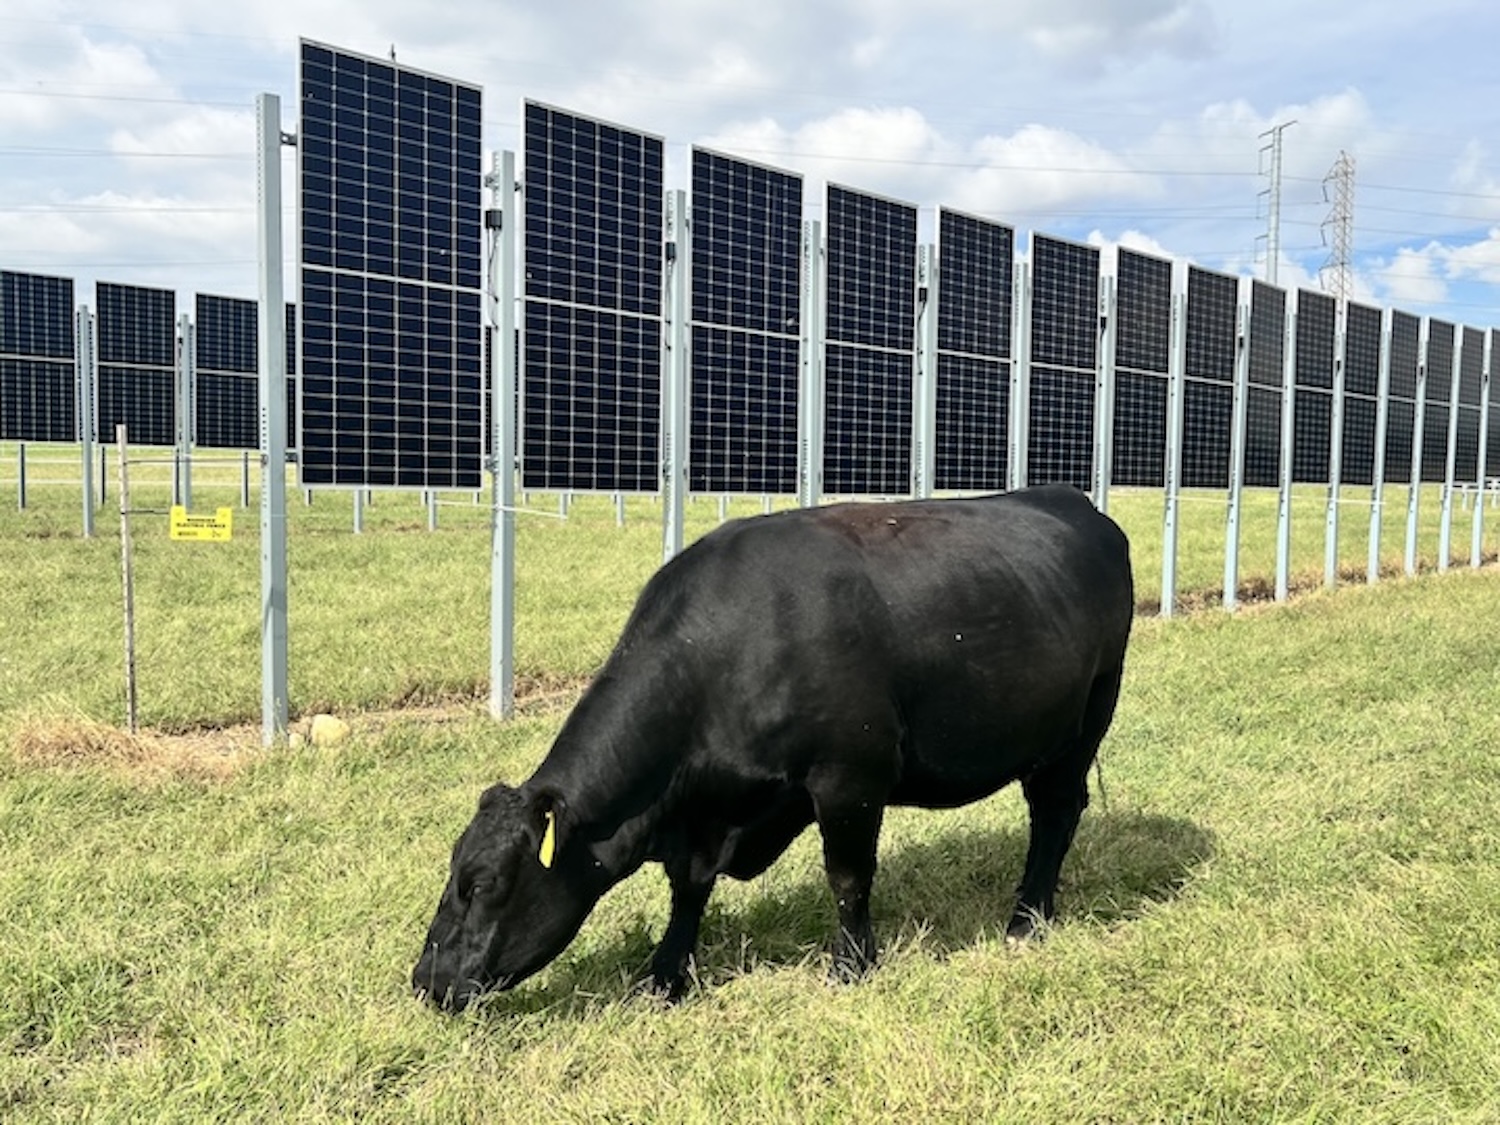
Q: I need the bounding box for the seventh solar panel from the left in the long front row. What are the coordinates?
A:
[1110,246,1172,488]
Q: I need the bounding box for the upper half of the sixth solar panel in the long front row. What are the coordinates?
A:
[1031,234,1100,372]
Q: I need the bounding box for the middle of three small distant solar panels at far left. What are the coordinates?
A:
[95,282,177,446]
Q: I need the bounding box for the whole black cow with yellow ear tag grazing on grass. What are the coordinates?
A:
[413,486,1134,1008]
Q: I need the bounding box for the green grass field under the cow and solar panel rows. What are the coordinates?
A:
[0,447,1500,1122]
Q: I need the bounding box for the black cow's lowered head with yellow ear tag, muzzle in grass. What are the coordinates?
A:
[411,785,599,1011]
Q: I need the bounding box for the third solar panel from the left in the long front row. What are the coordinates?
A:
[689,149,803,494]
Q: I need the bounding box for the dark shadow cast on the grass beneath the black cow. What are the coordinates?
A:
[462,812,1214,1020]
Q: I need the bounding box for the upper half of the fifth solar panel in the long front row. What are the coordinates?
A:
[938,209,1016,357]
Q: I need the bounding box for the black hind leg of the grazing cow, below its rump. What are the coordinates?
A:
[1005,669,1121,941]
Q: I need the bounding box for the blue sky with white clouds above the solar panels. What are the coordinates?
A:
[0,0,1500,327]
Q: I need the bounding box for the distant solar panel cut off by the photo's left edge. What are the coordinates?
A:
[0,270,78,441]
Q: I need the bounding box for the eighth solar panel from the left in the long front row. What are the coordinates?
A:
[1182,266,1239,488]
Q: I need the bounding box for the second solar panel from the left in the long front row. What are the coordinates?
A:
[521,102,665,492]
